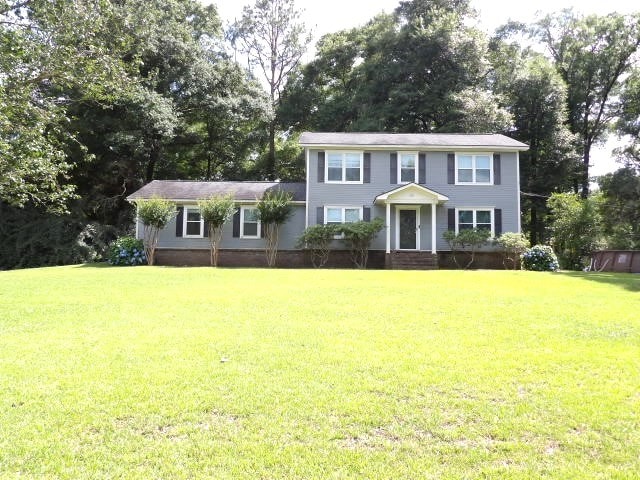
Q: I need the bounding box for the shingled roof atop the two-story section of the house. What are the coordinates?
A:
[300,132,529,150]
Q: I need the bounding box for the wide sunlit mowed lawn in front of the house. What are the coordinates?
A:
[0,266,640,479]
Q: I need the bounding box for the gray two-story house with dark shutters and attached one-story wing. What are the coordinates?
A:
[128,132,528,267]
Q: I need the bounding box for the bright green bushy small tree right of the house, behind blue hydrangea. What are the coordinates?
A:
[547,193,604,270]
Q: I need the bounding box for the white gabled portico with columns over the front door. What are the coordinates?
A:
[374,183,449,254]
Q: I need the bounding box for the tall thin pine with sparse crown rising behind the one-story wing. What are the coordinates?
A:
[229,0,311,179]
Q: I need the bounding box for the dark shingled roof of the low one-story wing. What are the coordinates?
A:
[127,180,306,202]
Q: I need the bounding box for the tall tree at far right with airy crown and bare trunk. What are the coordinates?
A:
[533,10,640,198]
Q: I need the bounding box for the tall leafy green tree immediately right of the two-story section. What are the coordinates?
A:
[490,31,580,245]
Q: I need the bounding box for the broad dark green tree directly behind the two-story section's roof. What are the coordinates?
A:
[280,0,510,132]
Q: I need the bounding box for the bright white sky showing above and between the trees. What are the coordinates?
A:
[203,0,640,175]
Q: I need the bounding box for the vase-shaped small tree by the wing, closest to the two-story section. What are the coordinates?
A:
[256,190,293,267]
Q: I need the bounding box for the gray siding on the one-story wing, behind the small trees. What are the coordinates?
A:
[138,205,305,250]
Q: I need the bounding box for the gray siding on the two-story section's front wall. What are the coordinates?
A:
[307,148,520,250]
